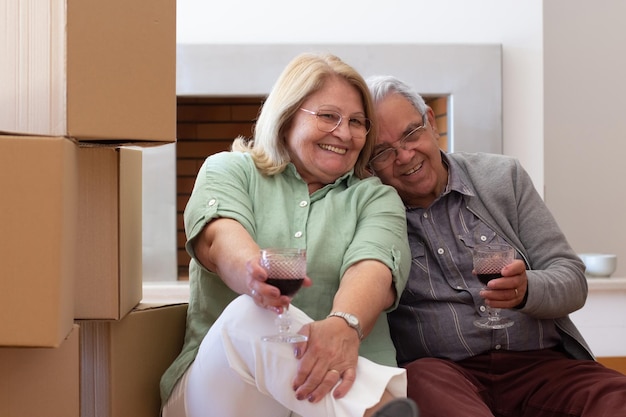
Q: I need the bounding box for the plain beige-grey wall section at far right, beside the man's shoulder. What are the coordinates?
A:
[540,0,626,277]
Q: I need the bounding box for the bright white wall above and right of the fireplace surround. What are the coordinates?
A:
[177,0,544,193]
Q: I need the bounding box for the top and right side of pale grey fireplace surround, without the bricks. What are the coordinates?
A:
[176,44,503,153]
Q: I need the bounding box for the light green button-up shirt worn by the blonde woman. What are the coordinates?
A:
[161,152,411,402]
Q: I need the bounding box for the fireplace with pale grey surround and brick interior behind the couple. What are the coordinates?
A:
[176,44,502,279]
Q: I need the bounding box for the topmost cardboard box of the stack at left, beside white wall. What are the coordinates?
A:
[0,0,176,142]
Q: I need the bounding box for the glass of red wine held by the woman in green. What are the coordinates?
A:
[261,248,307,343]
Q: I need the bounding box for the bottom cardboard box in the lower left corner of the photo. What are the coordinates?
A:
[0,325,80,417]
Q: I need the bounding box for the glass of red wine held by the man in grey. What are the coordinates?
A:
[472,244,515,329]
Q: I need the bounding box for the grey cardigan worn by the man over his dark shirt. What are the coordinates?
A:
[446,153,594,359]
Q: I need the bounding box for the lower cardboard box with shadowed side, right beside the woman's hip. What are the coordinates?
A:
[78,304,187,417]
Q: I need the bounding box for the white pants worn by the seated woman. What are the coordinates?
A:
[163,295,407,417]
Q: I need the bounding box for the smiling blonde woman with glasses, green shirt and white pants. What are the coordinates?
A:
[161,54,417,417]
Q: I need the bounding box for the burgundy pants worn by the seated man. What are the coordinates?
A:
[406,350,626,417]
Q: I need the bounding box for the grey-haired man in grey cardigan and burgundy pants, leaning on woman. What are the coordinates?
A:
[368,76,626,417]
